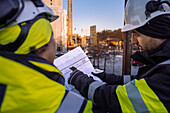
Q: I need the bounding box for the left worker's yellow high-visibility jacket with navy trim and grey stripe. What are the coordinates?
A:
[0,52,103,113]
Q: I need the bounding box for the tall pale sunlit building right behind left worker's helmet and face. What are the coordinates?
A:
[43,0,67,52]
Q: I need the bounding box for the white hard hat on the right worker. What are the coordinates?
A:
[122,0,170,32]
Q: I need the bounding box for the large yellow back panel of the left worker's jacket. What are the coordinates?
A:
[0,56,65,113]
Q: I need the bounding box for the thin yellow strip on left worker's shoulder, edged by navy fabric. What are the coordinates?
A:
[29,61,63,75]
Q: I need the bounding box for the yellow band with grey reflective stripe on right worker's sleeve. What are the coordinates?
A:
[116,79,168,113]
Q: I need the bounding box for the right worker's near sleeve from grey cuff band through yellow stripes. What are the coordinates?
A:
[75,79,167,113]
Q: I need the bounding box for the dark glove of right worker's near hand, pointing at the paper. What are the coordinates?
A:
[68,67,95,98]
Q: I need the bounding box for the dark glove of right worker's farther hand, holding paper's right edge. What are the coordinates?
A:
[92,72,123,85]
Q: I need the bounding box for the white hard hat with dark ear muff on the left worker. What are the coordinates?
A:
[0,0,59,30]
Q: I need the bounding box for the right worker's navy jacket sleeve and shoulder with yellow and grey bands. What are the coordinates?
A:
[87,60,170,113]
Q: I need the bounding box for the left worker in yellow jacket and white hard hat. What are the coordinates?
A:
[0,0,102,113]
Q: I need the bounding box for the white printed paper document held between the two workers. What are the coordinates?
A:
[54,47,100,92]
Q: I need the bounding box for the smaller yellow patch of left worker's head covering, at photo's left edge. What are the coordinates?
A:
[0,25,21,45]
